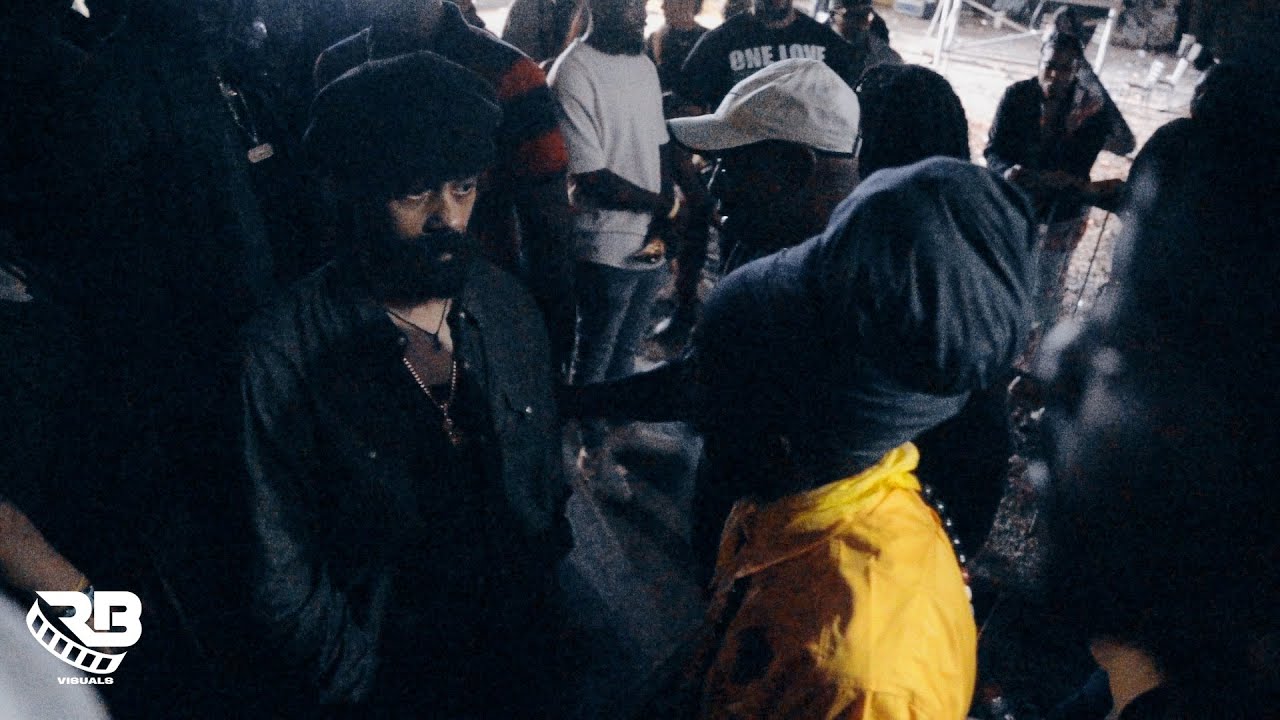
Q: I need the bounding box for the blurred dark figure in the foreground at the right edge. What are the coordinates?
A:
[1037,57,1280,720]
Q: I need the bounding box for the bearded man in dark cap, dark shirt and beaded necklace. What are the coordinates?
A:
[242,51,570,717]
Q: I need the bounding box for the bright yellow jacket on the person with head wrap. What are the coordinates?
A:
[700,443,978,720]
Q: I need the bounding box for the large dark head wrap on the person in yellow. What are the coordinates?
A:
[695,158,1036,482]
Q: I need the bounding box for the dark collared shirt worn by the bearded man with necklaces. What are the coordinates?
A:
[242,256,568,703]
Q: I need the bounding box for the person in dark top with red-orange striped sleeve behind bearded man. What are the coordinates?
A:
[315,0,573,365]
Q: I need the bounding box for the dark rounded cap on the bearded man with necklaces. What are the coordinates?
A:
[303,51,502,199]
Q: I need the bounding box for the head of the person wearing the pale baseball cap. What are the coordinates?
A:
[667,59,859,272]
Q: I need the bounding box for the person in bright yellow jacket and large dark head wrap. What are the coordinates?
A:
[692,158,1036,720]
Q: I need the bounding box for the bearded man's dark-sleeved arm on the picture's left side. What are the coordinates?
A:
[242,351,378,705]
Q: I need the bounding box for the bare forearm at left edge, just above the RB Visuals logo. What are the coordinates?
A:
[0,498,90,592]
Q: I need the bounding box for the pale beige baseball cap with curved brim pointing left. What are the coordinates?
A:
[667,58,860,155]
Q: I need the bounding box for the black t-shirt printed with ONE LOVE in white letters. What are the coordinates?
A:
[675,13,858,108]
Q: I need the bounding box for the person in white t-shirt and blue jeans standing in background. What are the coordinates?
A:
[549,0,680,501]
